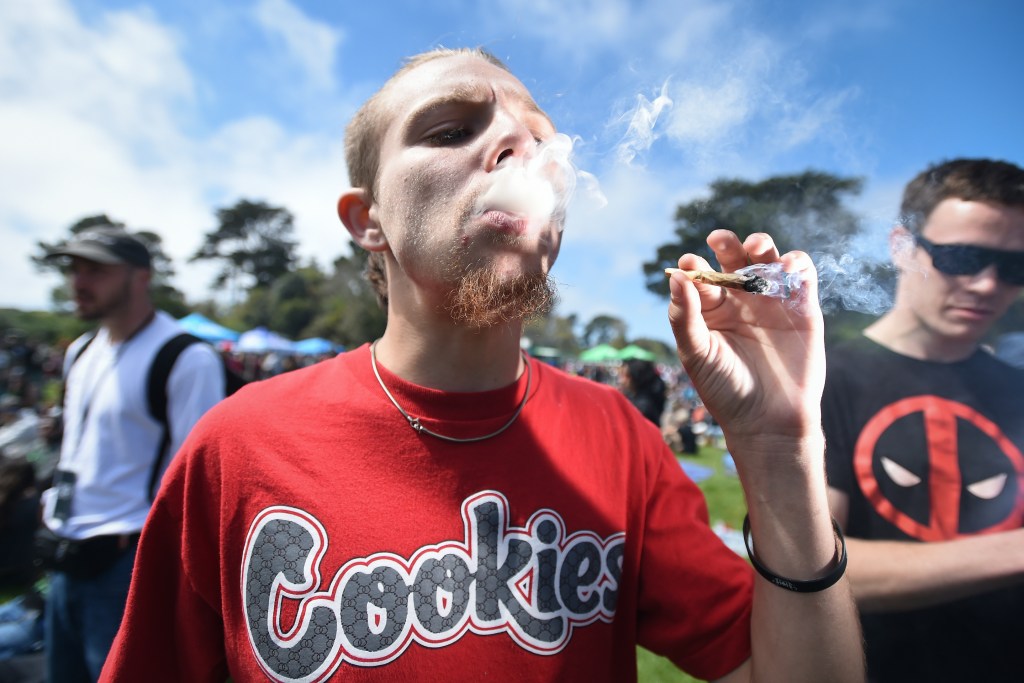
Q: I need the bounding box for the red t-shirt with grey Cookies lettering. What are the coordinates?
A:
[103,346,753,681]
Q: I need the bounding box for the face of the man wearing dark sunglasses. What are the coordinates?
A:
[900,199,1024,344]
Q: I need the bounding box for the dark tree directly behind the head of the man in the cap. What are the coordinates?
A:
[30,213,188,317]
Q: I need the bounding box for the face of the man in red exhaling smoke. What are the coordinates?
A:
[371,55,561,321]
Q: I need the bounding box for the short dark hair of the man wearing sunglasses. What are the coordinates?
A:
[899,159,1024,233]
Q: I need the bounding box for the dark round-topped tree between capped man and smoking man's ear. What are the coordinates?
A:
[189,200,297,288]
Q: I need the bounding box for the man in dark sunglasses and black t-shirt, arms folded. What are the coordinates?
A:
[822,159,1024,681]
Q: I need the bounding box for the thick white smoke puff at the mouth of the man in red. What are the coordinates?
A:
[476,133,603,231]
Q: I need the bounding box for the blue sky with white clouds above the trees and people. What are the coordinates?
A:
[0,0,1024,341]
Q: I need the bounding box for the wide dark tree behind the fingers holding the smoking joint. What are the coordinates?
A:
[643,171,863,298]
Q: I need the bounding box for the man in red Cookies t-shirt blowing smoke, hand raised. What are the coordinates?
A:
[103,50,862,683]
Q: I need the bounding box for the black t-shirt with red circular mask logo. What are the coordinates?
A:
[822,338,1024,683]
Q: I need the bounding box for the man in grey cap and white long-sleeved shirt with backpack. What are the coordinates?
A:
[38,227,224,681]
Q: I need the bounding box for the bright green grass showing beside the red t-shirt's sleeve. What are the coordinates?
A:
[637,446,746,683]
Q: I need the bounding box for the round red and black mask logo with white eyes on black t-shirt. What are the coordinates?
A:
[854,395,1024,542]
